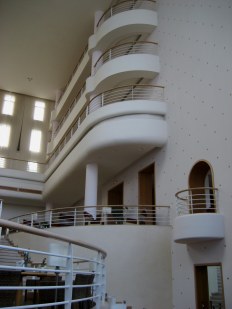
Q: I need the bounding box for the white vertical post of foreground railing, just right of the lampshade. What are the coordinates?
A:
[64,243,73,309]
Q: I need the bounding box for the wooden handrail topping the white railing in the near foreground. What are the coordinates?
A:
[0,219,107,257]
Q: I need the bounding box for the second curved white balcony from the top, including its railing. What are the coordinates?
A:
[86,42,160,93]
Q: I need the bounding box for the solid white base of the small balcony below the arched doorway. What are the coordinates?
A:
[173,213,225,244]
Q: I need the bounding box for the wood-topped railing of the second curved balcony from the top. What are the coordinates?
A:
[94,41,158,74]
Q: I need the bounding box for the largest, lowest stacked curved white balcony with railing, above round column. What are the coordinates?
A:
[44,85,167,202]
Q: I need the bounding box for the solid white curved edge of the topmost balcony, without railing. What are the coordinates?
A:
[88,9,158,53]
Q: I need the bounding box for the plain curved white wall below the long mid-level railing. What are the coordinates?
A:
[11,225,171,309]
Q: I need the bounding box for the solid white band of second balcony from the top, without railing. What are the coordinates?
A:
[86,54,160,95]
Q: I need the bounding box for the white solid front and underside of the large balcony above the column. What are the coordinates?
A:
[44,102,167,205]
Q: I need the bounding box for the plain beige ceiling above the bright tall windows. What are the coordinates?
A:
[0,0,111,100]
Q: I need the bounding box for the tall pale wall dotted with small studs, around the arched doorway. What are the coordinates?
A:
[103,0,232,309]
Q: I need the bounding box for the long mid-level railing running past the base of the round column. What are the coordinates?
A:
[10,205,170,229]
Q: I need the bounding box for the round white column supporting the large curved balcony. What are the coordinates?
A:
[84,163,98,219]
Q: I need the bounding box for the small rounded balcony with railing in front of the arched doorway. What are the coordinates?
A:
[174,187,224,244]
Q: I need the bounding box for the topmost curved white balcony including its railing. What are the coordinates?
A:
[89,0,157,51]
